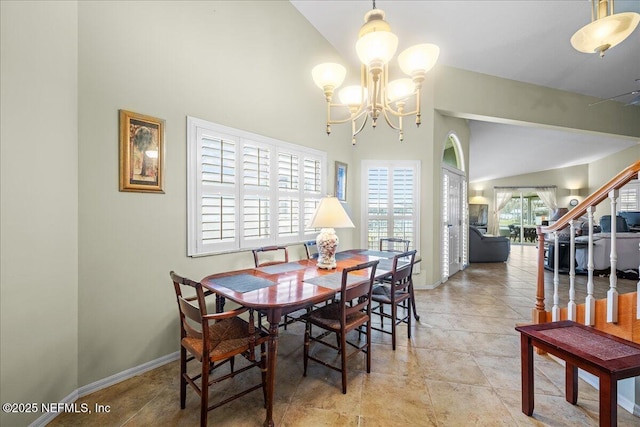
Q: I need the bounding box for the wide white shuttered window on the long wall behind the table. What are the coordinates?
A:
[187,117,327,256]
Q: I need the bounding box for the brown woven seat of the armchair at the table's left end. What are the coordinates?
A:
[182,317,258,360]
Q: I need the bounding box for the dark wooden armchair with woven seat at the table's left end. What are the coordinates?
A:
[169,271,268,426]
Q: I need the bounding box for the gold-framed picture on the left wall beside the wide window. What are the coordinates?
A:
[120,110,164,193]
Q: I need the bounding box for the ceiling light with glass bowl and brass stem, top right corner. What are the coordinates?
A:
[571,0,640,57]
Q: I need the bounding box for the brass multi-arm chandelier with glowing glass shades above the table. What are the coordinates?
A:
[311,0,440,145]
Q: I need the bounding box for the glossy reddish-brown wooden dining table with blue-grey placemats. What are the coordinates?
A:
[201,249,417,426]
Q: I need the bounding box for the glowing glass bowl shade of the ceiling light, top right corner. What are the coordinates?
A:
[571,12,640,53]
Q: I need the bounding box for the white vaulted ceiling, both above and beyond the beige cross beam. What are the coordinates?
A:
[291,0,640,181]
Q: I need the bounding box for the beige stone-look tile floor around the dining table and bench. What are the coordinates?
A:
[49,245,640,427]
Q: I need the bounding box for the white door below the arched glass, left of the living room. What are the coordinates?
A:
[442,167,465,281]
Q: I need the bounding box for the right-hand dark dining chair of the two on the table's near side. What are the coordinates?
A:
[371,250,416,351]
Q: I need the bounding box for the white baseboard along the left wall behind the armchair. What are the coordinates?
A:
[29,351,180,427]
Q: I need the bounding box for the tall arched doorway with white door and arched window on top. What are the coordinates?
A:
[440,132,468,282]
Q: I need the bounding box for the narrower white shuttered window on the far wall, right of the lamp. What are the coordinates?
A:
[362,160,420,254]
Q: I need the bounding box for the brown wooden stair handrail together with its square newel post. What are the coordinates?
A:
[532,160,640,323]
